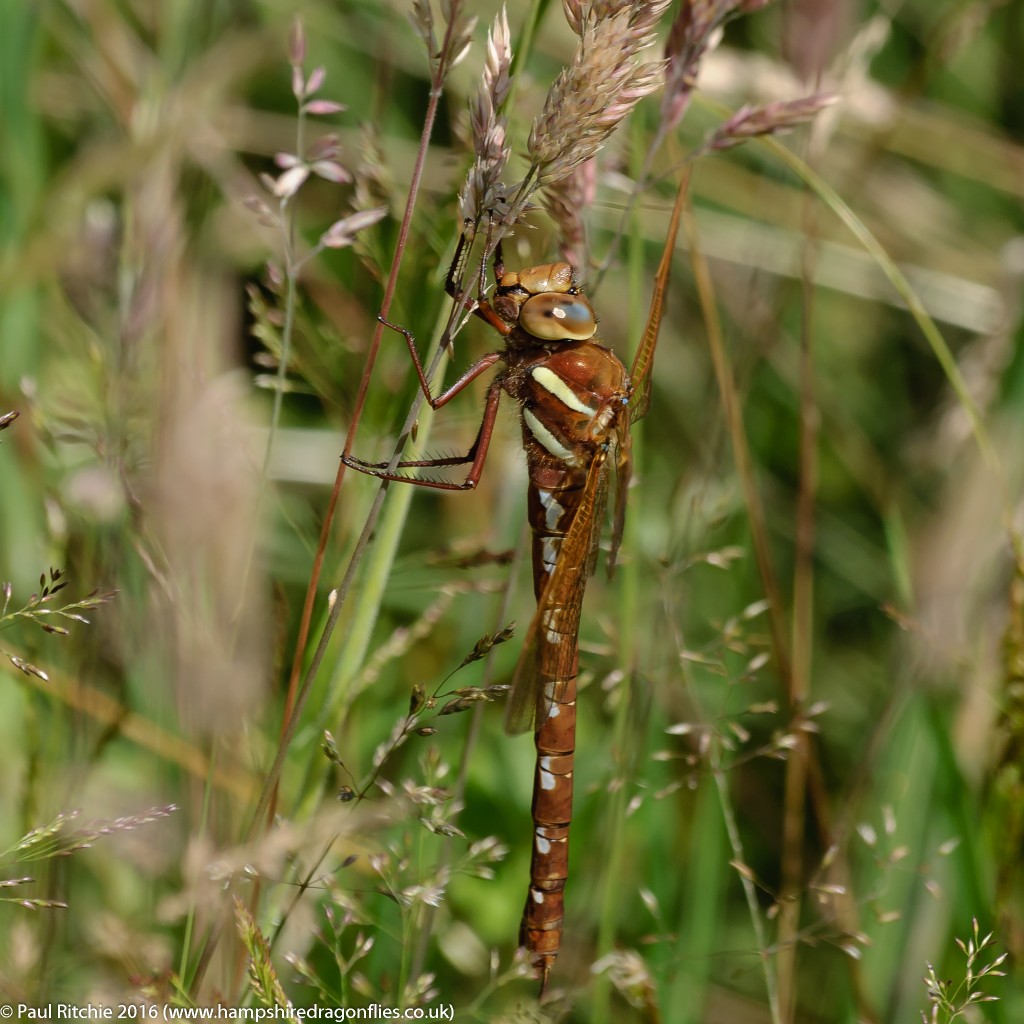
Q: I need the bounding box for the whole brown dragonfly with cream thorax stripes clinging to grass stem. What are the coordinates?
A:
[344,189,683,993]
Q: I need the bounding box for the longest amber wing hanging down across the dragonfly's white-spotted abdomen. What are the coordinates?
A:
[505,450,608,734]
